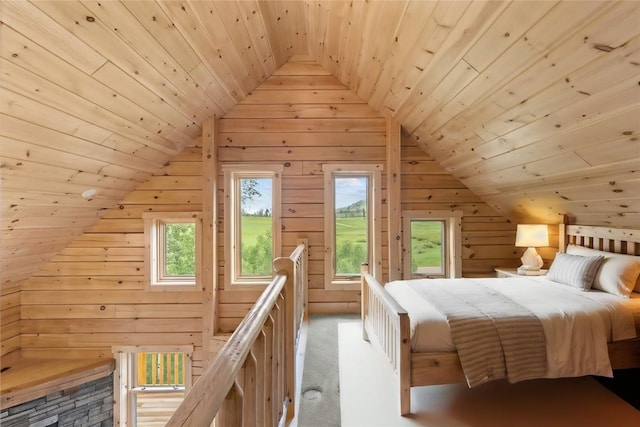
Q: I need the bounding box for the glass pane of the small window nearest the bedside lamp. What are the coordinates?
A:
[410,219,445,275]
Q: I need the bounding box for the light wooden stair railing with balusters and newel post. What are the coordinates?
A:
[167,244,307,427]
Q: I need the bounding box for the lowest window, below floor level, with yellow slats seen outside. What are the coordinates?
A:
[113,346,193,426]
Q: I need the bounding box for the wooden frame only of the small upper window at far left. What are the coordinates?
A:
[142,212,202,291]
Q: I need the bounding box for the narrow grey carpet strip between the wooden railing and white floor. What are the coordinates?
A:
[298,314,360,427]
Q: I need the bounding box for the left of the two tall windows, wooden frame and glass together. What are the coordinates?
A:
[223,165,282,285]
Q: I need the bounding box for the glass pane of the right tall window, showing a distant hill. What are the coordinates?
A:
[334,176,369,276]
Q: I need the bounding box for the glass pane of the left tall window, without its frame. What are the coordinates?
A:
[239,178,273,276]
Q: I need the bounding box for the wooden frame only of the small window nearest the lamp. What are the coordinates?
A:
[402,210,463,280]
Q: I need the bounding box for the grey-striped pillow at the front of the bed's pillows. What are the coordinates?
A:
[547,252,604,291]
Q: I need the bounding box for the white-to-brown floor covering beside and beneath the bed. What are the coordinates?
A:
[338,323,640,427]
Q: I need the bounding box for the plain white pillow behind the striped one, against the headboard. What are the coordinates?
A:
[567,245,640,298]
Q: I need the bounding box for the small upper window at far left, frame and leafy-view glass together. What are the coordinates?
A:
[143,212,201,290]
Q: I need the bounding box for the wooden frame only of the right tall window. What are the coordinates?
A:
[322,163,383,290]
